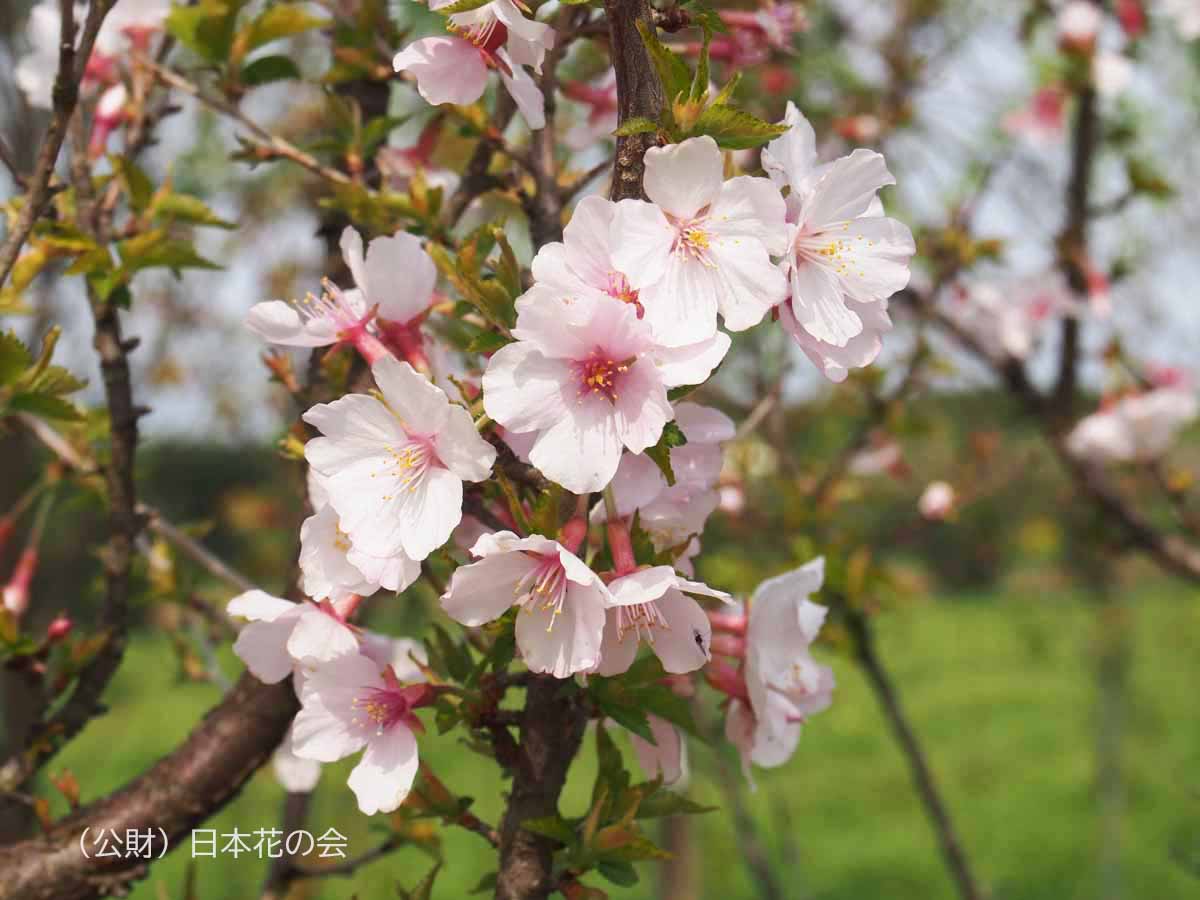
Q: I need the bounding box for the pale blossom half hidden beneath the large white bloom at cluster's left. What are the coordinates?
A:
[300,469,421,601]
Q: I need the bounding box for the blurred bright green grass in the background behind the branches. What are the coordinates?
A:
[37,587,1200,900]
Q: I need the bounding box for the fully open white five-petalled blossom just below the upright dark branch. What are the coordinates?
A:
[612,136,787,346]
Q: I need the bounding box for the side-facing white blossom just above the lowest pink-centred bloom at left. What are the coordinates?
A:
[226,590,359,684]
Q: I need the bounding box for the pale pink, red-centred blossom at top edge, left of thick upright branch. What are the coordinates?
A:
[392,0,554,131]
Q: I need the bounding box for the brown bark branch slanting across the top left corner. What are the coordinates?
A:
[0,0,115,287]
